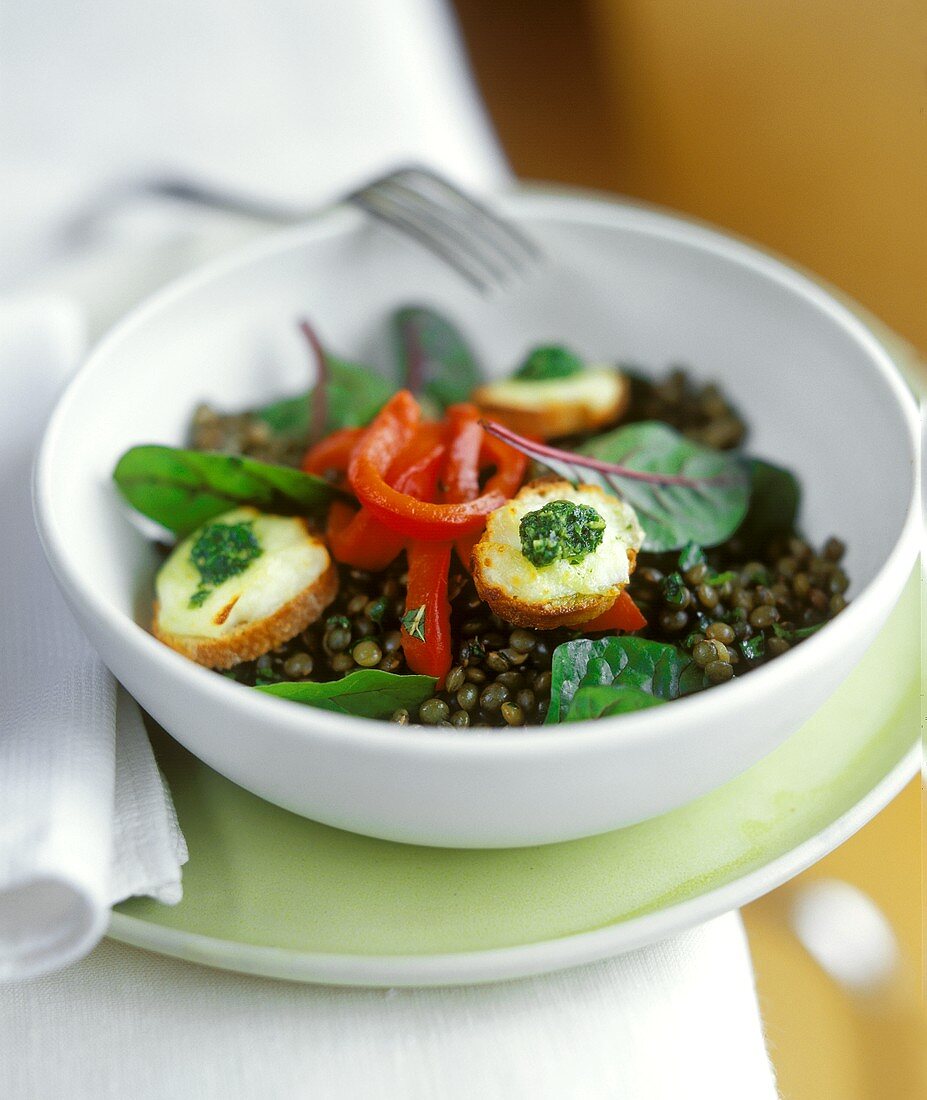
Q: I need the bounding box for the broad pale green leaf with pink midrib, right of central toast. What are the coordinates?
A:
[580,420,749,552]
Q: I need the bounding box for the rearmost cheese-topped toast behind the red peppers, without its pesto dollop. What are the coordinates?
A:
[471,366,631,439]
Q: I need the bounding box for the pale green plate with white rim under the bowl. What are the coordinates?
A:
[110,576,919,986]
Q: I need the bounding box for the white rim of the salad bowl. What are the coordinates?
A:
[32,185,919,759]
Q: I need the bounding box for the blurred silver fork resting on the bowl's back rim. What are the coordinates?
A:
[64,166,544,295]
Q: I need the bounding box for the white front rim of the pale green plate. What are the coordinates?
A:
[107,735,920,988]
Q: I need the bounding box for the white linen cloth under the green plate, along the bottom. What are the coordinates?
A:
[0,913,776,1100]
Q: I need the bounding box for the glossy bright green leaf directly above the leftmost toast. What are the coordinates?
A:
[112,443,338,537]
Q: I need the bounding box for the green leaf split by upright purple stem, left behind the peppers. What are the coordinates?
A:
[254,352,393,442]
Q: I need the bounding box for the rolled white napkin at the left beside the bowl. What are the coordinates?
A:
[0,299,186,979]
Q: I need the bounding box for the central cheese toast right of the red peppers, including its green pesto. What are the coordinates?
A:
[471,479,643,629]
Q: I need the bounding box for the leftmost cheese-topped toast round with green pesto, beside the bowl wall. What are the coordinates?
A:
[153,508,338,669]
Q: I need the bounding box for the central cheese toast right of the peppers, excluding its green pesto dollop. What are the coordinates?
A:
[471,479,643,629]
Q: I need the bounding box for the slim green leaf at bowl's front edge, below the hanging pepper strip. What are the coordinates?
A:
[257,669,435,718]
